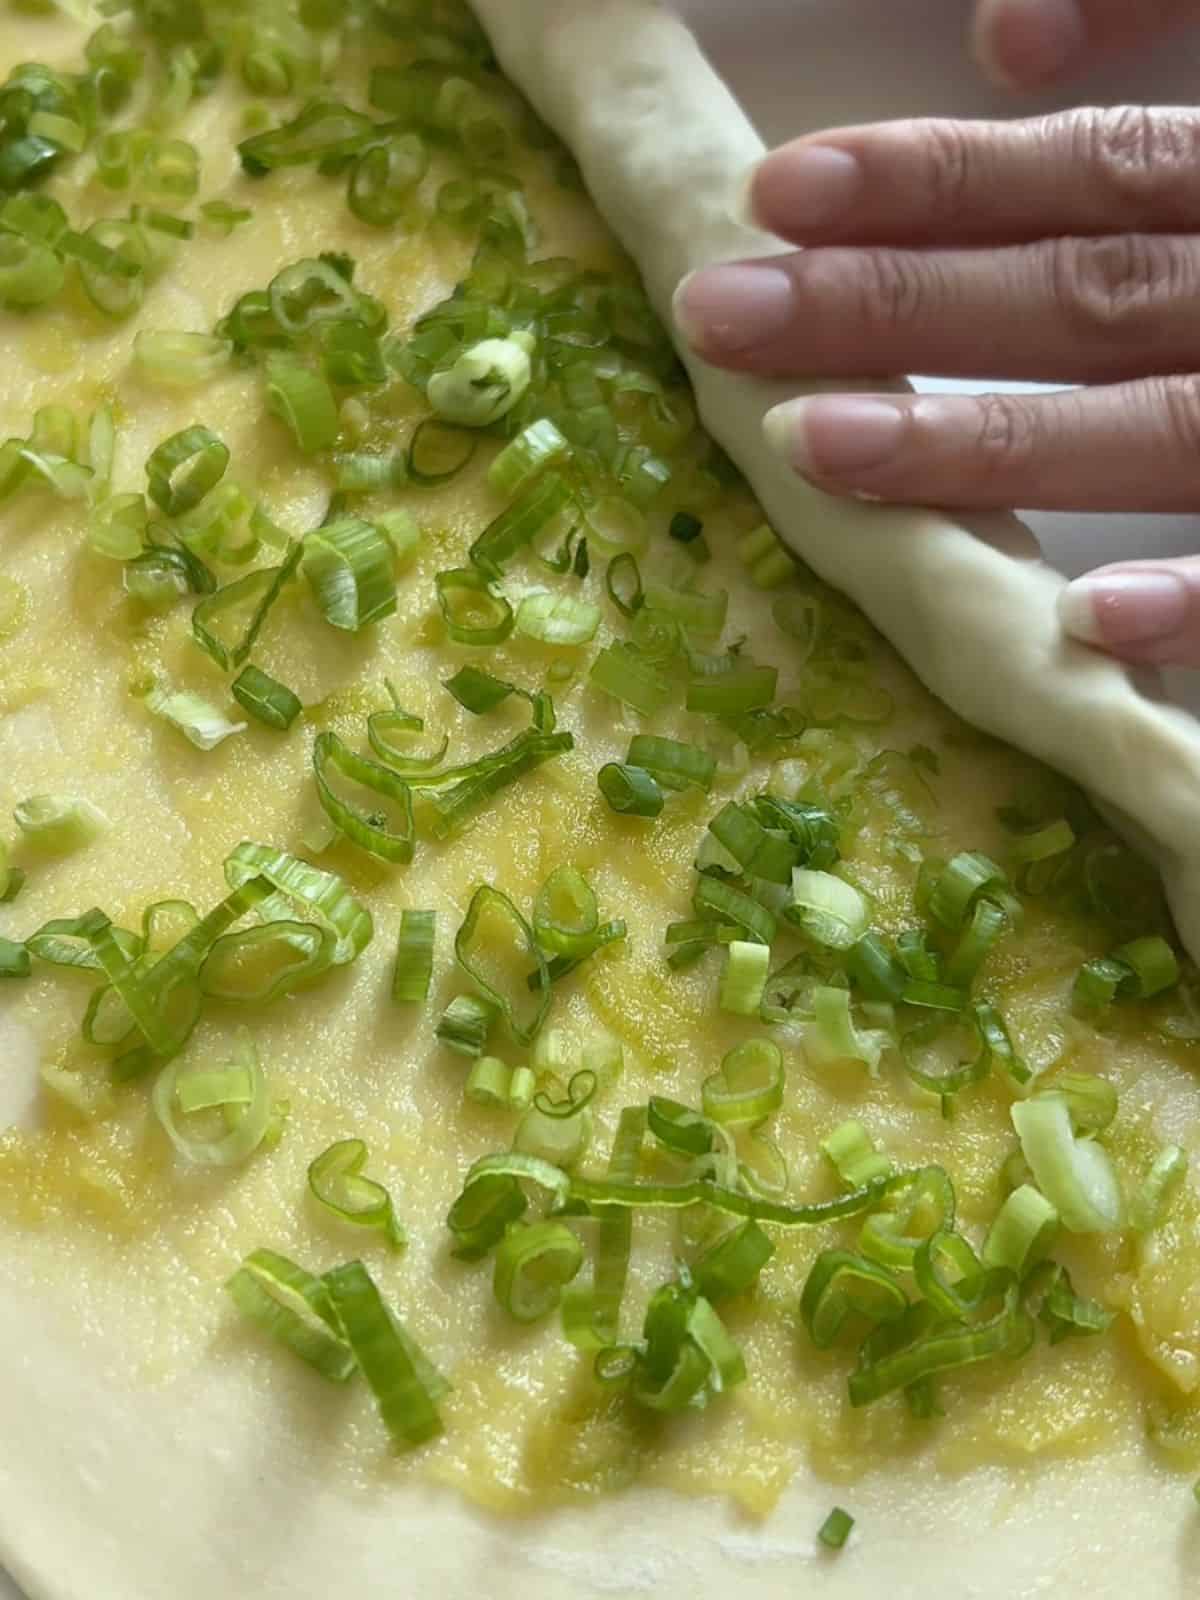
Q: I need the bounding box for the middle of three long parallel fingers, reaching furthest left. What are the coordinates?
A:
[675,234,1200,382]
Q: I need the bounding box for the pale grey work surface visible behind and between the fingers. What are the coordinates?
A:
[0,0,1200,1600]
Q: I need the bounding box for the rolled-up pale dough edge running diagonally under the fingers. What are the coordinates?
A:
[472,0,1200,958]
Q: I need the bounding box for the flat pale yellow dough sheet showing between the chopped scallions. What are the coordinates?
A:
[0,0,1200,1600]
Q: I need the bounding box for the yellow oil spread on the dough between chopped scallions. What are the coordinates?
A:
[0,16,1200,1512]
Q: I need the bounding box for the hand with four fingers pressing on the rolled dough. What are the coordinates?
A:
[677,104,1200,666]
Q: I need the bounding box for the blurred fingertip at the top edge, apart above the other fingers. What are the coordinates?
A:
[974,0,1200,90]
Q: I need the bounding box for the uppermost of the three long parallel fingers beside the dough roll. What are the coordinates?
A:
[746,106,1200,246]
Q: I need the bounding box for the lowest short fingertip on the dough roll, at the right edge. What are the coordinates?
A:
[1058,555,1200,667]
